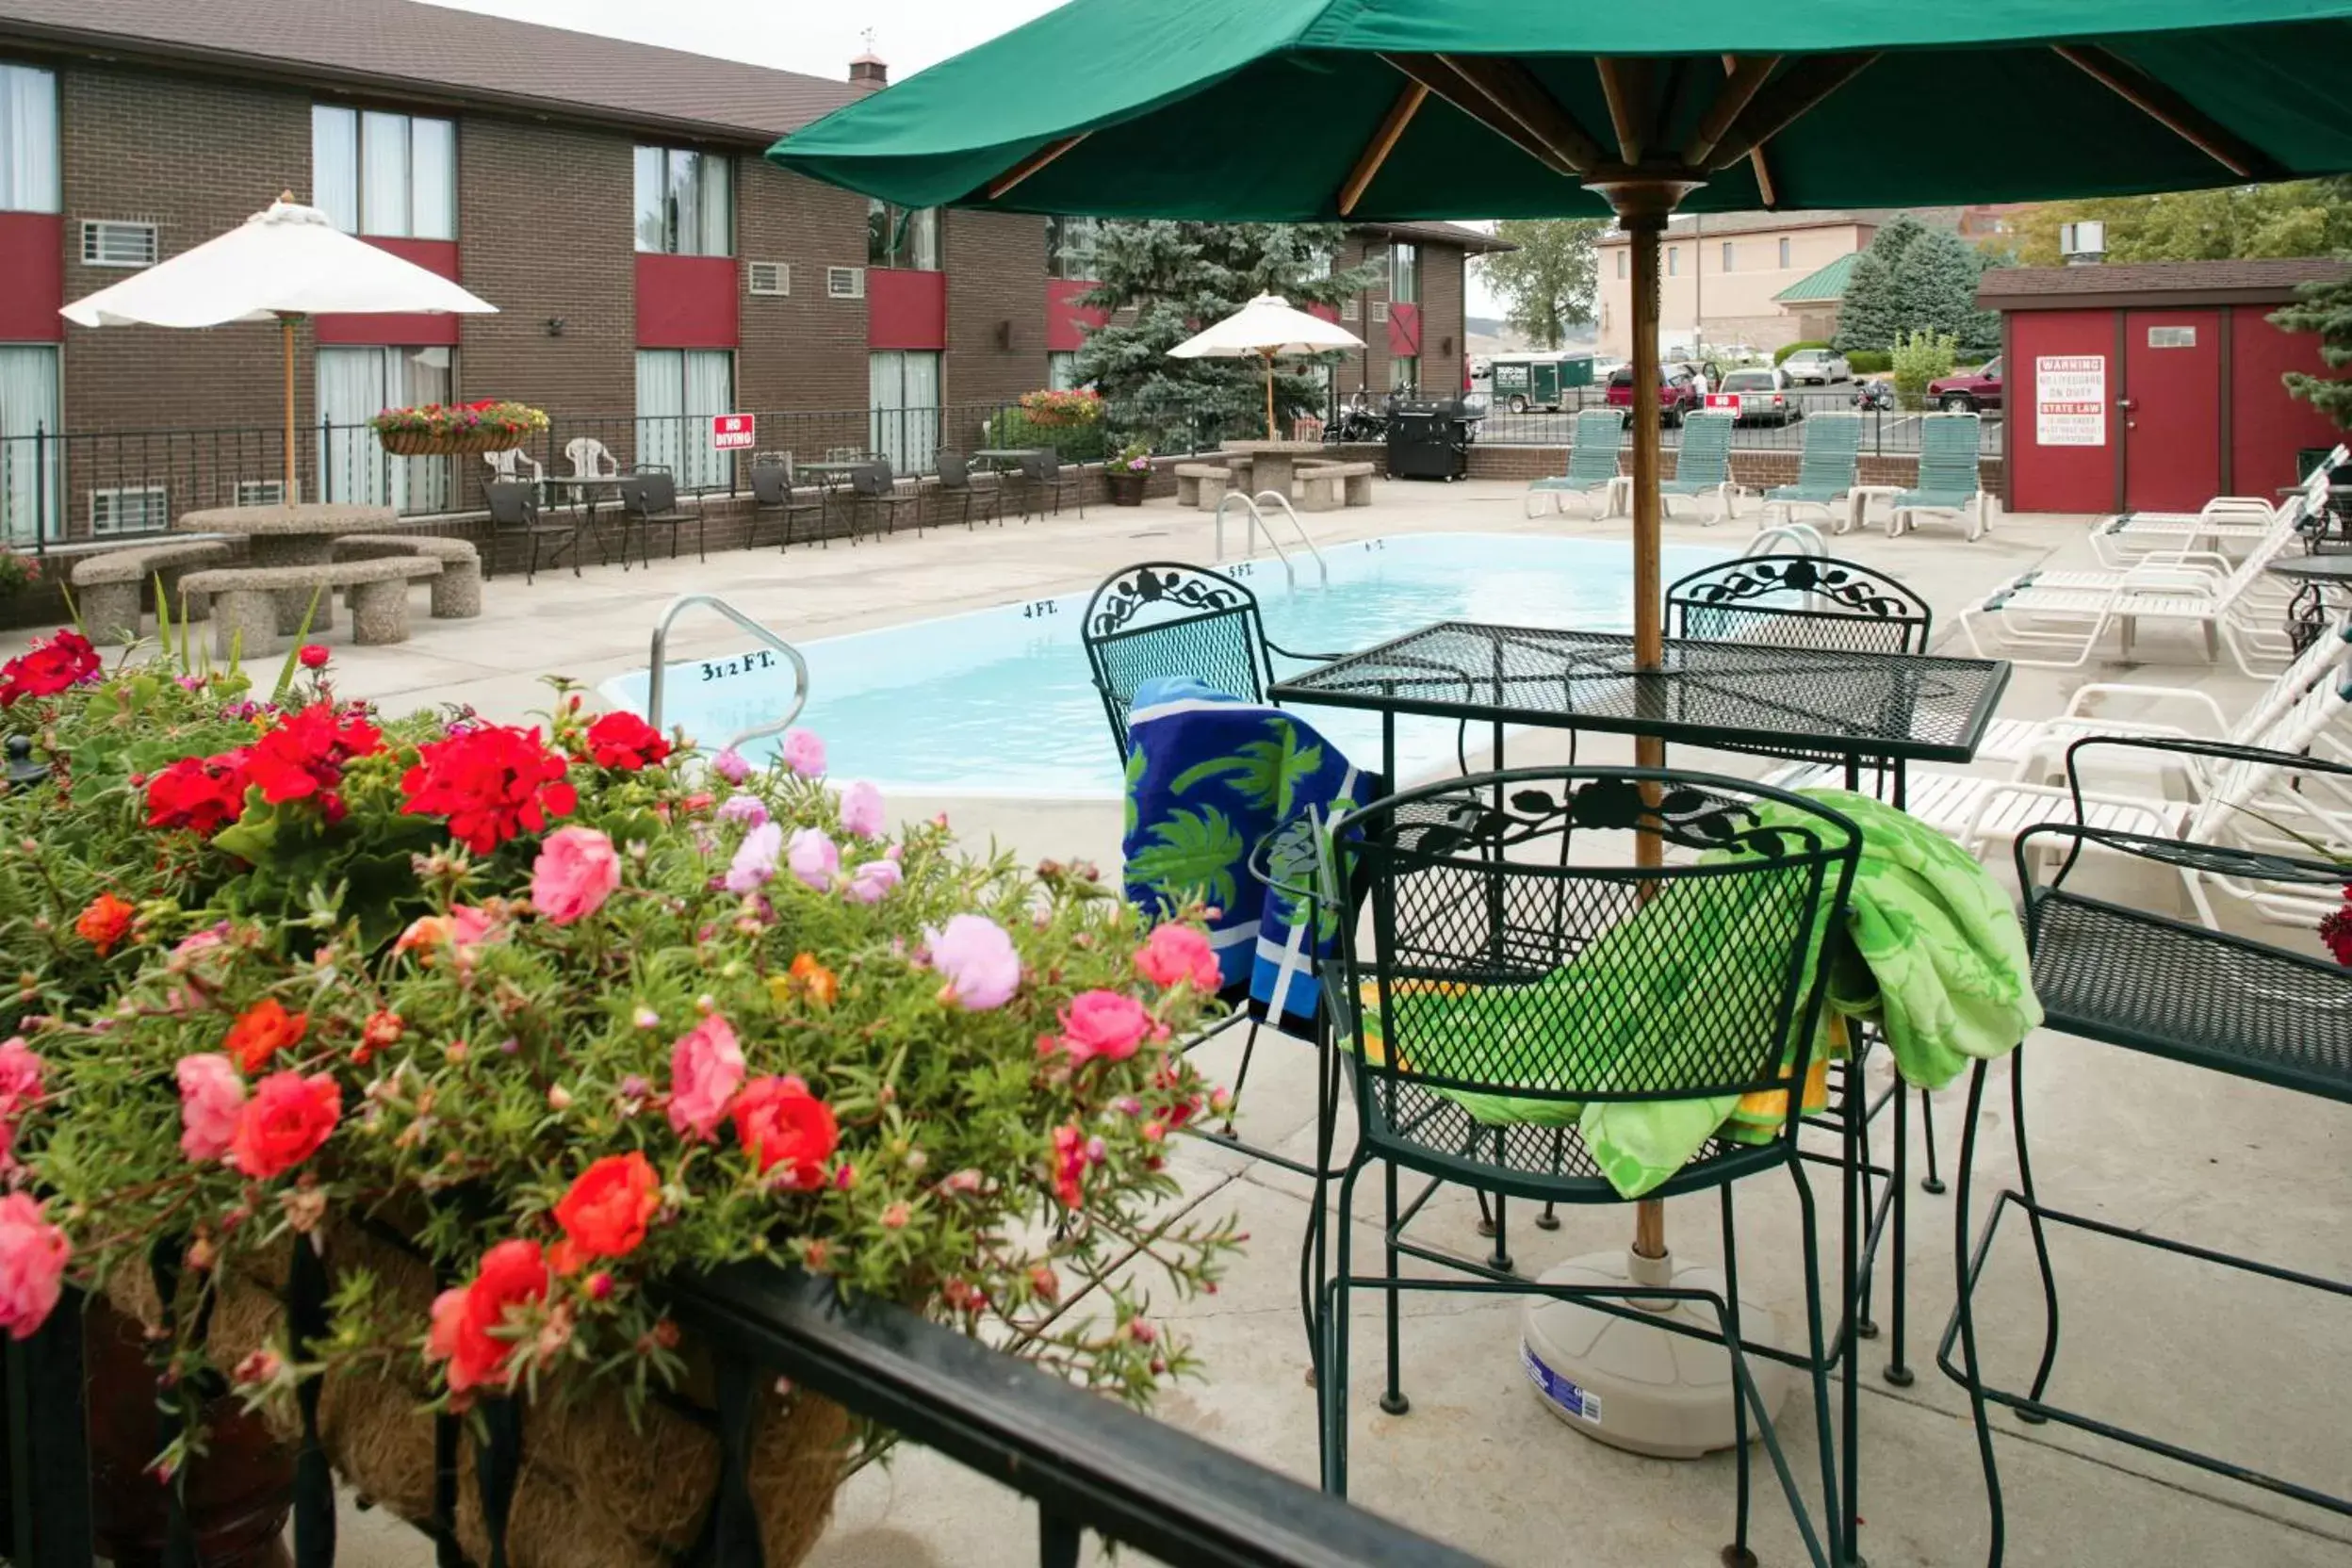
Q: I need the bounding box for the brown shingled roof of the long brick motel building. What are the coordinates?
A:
[0,0,866,146]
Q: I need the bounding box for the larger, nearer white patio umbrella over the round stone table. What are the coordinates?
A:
[61,193,498,505]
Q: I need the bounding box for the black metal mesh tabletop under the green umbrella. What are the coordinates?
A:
[1272,621,2009,761]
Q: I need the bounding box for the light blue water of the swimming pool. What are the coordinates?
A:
[588,533,1724,797]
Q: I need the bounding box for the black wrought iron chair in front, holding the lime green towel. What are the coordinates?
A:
[1317,769,1860,1563]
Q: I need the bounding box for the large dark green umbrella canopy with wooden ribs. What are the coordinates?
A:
[769,0,2352,221]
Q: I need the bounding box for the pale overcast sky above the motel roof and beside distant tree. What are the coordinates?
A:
[433,0,1498,315]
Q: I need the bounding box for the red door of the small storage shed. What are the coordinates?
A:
[2116,310,2223,513]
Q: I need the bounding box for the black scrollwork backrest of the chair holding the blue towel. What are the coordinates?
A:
[1080,562,1275,761]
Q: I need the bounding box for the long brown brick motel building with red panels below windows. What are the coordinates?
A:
[0,0,1491,538]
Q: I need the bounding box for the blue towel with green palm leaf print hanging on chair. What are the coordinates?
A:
[1124,677,1385,1027]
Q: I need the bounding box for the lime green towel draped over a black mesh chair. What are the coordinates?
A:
[1364,790,2042,1197]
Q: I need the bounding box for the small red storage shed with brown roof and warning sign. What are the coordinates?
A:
[1976,258,2345,513]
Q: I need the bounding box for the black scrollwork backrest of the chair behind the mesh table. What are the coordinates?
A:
[1665,555,1936,654]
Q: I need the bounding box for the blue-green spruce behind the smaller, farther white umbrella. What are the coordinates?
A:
[1075,221,1383,447]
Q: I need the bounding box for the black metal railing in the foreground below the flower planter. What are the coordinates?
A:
[7,1265,1479,1568]
